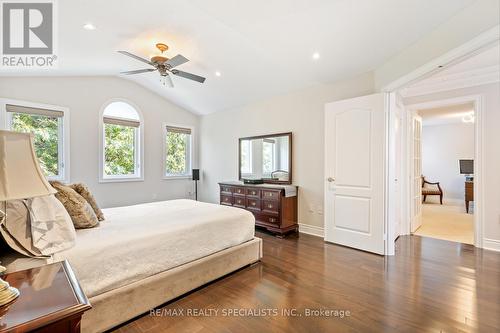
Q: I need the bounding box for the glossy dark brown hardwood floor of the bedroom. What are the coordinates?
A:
[116,232,500,333]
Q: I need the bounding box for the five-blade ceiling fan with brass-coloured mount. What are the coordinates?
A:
[118,43,205,87]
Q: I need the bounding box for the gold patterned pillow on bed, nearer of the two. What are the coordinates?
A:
[50,181,99,229]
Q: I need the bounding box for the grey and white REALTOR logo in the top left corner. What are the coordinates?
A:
[1,0,57,68]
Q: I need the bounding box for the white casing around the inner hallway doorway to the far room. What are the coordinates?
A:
[402,95,485,248]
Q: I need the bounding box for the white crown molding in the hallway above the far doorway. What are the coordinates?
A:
[401,65,500,97]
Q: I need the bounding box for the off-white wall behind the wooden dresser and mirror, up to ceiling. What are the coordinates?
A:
[200,73,373,228]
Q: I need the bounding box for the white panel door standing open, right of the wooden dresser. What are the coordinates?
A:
[325,94,386,254]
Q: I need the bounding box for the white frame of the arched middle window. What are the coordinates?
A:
[99,98,144,183]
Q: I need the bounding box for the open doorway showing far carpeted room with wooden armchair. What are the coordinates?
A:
[411,103,475,244]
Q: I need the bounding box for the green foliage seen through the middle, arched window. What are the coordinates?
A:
[104,124,137,176]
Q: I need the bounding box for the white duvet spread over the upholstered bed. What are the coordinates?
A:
[54,200,255,297]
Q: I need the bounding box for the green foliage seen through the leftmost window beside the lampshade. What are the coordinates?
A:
[12,113,58,176]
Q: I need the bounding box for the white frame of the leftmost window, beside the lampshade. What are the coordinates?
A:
[0,98,71,183]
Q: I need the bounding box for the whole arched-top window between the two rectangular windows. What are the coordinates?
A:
[100,101,143,181]
